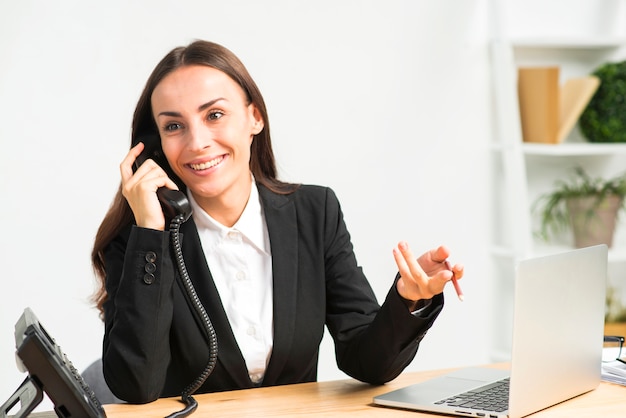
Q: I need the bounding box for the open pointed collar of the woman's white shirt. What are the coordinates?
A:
[188,181,270,254]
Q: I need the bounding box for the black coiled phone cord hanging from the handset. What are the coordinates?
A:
[166,214,217,418]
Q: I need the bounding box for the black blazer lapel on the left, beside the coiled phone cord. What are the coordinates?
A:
[181,221,252,387]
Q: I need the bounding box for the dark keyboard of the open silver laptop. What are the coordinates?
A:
[435,377,509,412]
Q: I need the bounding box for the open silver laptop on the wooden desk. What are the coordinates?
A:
[374,245,608,418]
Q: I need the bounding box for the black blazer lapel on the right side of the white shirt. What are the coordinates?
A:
[258,185,298,385]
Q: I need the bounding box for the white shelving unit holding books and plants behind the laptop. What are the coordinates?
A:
[489,0,626,364]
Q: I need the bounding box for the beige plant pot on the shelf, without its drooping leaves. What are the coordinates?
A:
[567,195,623,248]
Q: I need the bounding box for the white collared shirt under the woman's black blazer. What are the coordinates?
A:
[189,182,273,383]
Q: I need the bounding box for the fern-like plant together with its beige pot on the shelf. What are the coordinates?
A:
[533,167,626,248]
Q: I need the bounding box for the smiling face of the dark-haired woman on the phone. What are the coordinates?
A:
[151,65,263,204]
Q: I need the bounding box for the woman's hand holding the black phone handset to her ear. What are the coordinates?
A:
[120,142,178,231]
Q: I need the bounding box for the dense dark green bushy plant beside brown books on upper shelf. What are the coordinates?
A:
[578,61,626,142]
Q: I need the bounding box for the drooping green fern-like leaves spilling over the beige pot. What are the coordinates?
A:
[533,167,626,240]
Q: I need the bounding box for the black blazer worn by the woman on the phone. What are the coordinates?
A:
[103,186,443,403]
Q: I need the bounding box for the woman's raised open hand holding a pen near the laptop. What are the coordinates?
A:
[393,242,463,301]
